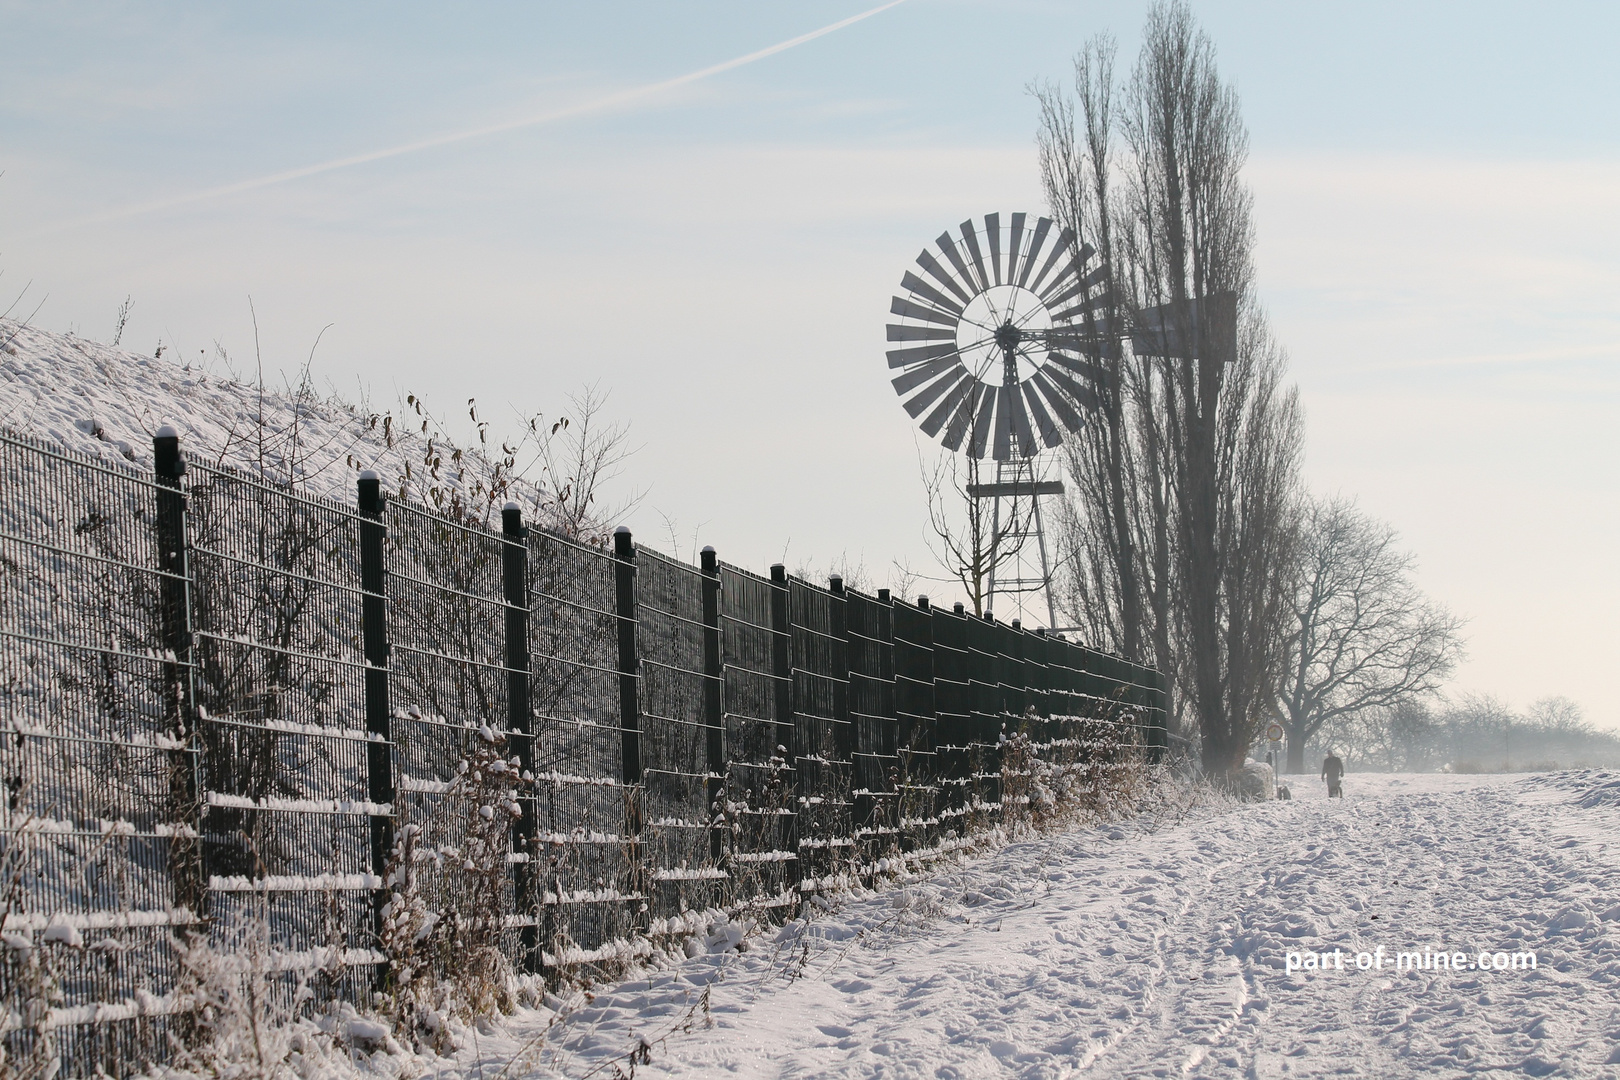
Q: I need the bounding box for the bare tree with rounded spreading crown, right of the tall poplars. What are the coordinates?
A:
[1280,497,1463,772]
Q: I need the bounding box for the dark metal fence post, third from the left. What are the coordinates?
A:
[501,502,539,973]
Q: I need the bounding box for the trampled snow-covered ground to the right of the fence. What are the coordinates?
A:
[441,772,1620,1077]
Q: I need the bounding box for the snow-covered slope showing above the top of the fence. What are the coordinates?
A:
[0,319,541,521]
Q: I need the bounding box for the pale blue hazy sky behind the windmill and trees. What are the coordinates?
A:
[0,0,1620,724]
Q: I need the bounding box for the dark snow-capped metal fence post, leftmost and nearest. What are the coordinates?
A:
[152,424,207,918]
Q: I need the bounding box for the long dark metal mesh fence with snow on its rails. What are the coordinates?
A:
[0,431,1163,1075]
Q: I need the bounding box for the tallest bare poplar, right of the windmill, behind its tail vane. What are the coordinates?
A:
[1116,0,1302,776]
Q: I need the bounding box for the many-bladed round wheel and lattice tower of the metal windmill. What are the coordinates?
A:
[888,214,1119,627]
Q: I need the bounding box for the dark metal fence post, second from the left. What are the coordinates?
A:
[358,470,400,958]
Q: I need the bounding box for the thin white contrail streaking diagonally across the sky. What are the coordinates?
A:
[31,0,906,236]
